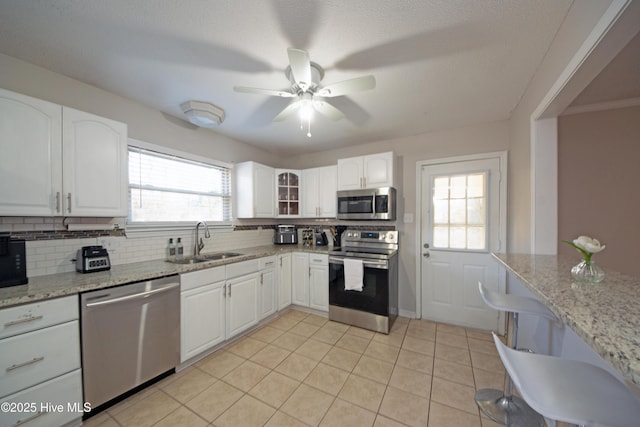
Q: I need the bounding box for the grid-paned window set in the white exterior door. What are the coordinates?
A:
[432,172,487,251]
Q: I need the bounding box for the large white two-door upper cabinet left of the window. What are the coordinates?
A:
[0,89,127,217]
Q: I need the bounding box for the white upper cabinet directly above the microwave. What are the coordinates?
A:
[338,151,394,190]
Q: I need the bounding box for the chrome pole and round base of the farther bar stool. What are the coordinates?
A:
[475,312,544,427]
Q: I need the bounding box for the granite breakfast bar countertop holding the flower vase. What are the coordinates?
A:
[493,254,640,387]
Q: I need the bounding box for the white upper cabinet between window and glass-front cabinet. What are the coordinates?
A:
[235,162,276,218]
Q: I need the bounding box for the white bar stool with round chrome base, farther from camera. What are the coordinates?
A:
[475,282,560,427]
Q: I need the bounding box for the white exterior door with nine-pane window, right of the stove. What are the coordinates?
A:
[420,154,506,331]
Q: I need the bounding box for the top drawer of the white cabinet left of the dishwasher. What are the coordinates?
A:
[0,295,78,339]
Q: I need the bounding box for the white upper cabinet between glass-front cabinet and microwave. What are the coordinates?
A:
[301,166,338,218]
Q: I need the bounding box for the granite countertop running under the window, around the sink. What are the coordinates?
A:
[0,245,330,308]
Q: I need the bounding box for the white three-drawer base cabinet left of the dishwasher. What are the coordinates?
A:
[0,296,83,427]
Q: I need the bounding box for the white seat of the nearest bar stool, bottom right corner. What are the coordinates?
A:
[493,334,640,427]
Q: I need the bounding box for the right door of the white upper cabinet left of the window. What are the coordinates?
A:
[62,107,128,217]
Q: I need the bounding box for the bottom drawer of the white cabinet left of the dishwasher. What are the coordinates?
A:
[0,369,84,427]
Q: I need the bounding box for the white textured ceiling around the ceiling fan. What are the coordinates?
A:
[0,0,571,155]
